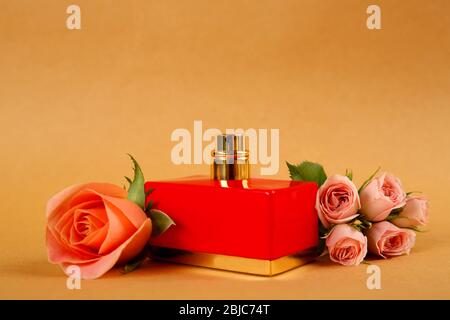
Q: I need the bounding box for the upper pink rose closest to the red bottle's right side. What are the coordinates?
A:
[316,175,360,228]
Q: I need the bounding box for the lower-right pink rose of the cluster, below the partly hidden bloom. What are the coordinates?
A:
[367,221,416,258]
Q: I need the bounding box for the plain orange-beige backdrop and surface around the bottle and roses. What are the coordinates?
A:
[0,0,450,298]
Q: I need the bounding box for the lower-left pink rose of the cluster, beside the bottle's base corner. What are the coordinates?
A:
[326,224,367,266]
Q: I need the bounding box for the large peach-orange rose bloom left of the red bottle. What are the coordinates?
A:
[46,183,152,279]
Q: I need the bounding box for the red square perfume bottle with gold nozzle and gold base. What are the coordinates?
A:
[145,135,318,276]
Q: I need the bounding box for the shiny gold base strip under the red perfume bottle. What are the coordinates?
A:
[151,247,317,276]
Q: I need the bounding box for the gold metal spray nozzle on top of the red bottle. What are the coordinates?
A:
[211,134,250,180]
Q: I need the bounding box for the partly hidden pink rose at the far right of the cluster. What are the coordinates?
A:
[391,196,428,228]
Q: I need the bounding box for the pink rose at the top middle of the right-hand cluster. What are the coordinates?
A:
[359,172,406,222]
